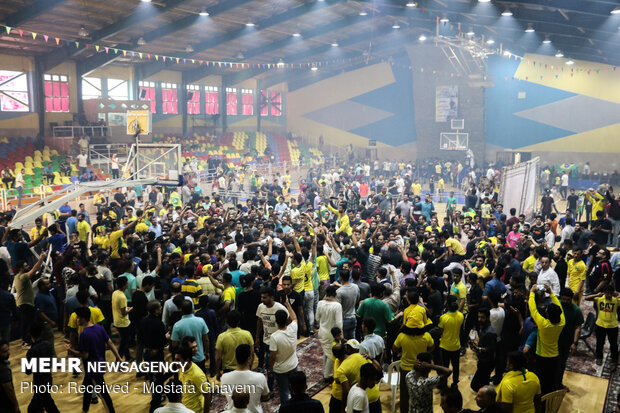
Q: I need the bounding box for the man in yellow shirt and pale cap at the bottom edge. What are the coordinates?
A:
[334,339,382,412]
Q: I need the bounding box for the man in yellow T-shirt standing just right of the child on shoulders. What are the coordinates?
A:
[438,295,465,386]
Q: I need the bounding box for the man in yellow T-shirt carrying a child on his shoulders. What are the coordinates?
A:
[392,327,435,412]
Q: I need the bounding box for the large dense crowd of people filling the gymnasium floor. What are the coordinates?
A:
[0,162,620,413]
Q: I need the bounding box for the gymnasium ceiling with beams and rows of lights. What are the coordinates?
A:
[0,0,620,76]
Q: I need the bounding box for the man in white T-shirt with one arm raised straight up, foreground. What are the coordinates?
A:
[269,297,299,402]
